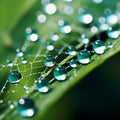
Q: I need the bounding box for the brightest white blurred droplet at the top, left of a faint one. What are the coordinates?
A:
[43,3,57,15]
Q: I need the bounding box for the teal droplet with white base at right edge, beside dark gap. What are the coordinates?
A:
[107,28,120,39]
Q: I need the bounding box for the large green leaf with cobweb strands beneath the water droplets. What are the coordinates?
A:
[0,0,120,120]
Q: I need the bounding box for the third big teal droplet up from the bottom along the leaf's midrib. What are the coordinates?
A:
[53,66,67,81]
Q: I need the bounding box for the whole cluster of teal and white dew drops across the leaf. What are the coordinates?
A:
[1,0,120,117]
